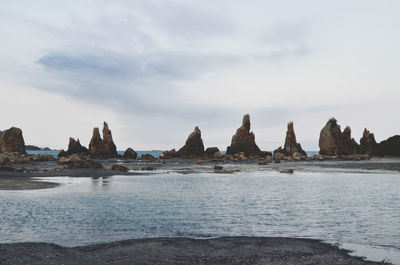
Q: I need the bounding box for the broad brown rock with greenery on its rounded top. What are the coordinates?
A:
[319,118,360,156]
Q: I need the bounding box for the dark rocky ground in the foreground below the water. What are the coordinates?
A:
[0,237,384,265]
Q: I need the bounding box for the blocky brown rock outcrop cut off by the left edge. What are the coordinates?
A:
[0,127,26,154]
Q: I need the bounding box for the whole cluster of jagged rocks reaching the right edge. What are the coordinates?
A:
[319,118,400,157]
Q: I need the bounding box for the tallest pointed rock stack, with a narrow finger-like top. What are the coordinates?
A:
[226,114,261,156]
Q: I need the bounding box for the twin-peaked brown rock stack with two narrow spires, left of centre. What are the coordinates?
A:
[89,122,118,158]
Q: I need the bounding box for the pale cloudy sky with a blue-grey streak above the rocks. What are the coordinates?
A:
[0,0,400,150]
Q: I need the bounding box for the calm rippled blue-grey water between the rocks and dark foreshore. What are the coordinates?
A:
[0,172,400,264]
